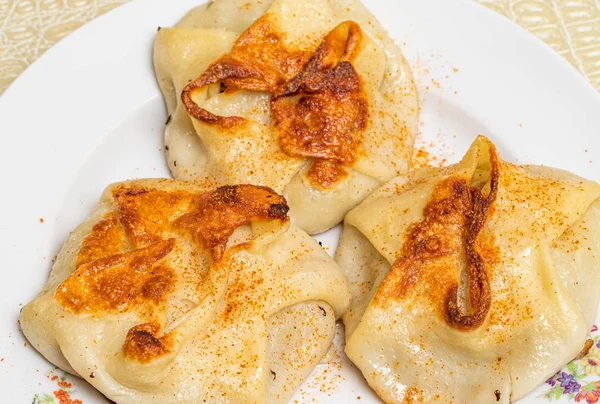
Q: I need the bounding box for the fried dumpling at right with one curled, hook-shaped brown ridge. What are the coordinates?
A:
[336,137,600,403]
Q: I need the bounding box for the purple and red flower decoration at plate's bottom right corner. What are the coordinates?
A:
[540,325,600,404]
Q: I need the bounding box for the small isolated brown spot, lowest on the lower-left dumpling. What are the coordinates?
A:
[123,323,173,363]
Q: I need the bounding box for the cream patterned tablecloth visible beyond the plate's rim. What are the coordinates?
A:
[0,0,600,94]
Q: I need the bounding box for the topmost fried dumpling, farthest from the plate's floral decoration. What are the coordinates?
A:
[154,0,418,234]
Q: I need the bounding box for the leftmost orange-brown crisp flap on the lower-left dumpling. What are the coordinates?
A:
[55,239,175,315]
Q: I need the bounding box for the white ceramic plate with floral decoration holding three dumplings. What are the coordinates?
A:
[0,0,600,404]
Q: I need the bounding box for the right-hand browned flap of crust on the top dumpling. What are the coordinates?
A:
[271,22,369,184]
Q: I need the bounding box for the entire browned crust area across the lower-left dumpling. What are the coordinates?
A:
[54,184,289,363]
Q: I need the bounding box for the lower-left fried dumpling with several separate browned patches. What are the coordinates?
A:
[20,180,350,404]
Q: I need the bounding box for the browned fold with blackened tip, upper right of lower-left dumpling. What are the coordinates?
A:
[174,185,289,260]
